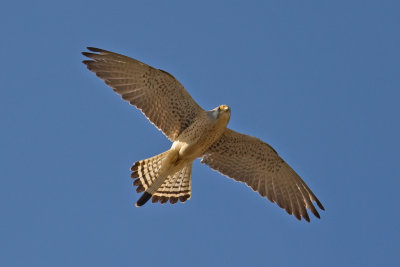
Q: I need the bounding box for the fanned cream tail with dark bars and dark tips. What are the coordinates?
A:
[131,151,192,206]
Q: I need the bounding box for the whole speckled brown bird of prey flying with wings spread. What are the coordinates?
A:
[82,47,324,222]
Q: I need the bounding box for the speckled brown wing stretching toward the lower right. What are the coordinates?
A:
[201,129,324,221]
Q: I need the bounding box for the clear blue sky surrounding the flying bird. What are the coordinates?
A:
[0,0,400,266]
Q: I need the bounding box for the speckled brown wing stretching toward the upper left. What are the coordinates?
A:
[82,47,204,141]
